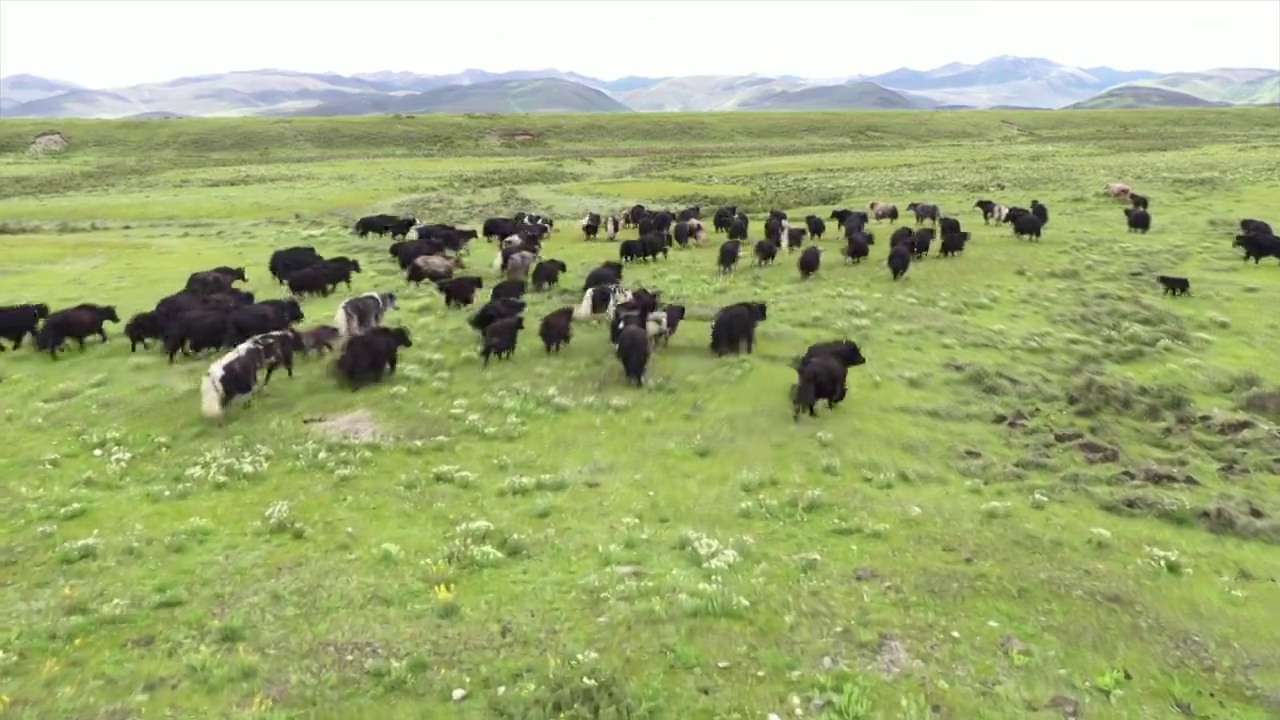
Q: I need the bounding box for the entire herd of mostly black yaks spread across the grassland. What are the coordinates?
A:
[0,183,1280,420]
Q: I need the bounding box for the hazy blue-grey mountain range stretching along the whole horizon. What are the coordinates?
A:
[0,55,1280,118]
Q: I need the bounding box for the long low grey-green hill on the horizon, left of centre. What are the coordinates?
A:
[282,79,631,115]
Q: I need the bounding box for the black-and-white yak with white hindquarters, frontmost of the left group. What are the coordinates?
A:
[200,331,303,420]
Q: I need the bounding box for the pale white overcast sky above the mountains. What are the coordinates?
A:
[0,0,1280,87]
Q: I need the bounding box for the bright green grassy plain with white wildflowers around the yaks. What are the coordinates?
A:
[0,110,1280,720]
